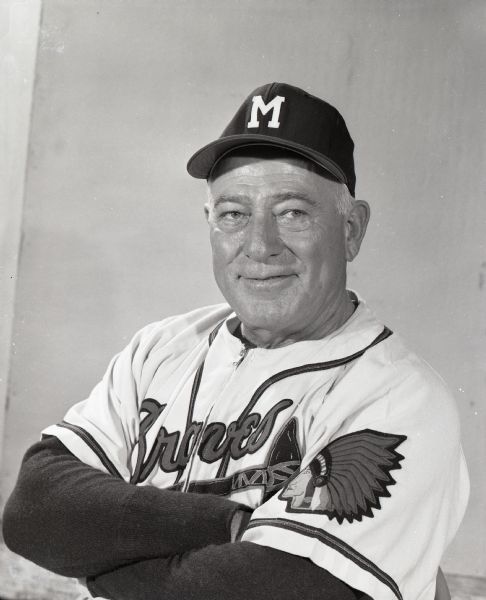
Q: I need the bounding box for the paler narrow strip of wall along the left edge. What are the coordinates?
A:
[0,0,40,461]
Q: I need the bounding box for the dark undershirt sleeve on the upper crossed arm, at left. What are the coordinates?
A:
[3,437,247,577]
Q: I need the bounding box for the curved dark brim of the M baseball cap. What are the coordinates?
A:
[187,133,348,185]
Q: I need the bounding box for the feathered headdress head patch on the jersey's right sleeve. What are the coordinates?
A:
[279,429,407,524]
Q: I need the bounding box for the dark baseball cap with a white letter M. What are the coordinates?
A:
[187,82,356,196]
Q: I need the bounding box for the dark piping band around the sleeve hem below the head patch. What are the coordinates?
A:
[246,519,403,600]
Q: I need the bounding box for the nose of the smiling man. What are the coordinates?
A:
[244,213,283,262]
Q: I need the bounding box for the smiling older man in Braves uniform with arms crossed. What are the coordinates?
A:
[4,83,468,600]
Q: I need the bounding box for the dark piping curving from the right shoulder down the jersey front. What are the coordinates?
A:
[216,327,393,477]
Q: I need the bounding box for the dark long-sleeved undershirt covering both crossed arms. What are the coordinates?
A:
[3,438,360,600]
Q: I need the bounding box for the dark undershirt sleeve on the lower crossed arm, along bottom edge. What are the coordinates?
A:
[88,542,362,600]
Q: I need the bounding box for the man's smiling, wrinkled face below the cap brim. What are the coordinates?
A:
[206,150,356,338]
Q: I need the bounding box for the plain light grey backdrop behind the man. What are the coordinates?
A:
[0,0,486,598]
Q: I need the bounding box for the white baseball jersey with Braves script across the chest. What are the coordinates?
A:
[43,301,469,600]
